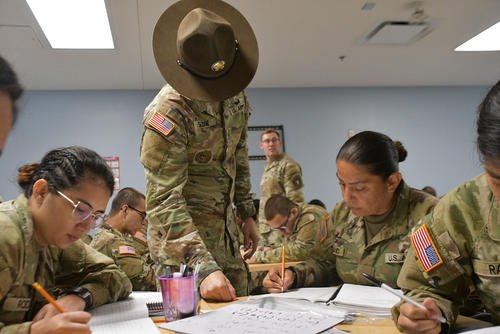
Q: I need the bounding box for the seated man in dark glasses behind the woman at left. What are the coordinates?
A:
[90,188,157,291]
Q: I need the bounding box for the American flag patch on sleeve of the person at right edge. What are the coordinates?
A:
[411,224,443,272]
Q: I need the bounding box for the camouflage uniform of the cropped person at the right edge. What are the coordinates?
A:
[394,174,500,327]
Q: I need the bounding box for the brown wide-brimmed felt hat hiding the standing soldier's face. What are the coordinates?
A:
[153,0,259,101]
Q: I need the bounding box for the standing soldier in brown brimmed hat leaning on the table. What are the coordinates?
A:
[141,0,259,301]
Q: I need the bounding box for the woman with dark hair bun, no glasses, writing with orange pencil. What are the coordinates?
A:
[264,131,437,292]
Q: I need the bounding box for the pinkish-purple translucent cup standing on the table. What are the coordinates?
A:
[158,275,198,322]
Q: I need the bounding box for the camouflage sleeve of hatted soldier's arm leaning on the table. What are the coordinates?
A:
[140,110,220,276]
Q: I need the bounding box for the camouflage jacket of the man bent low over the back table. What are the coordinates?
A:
[253,204,328,263]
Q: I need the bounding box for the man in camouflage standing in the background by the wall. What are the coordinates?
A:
[257,129,304,252]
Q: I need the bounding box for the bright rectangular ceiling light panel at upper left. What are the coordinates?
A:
[26,0,114,49]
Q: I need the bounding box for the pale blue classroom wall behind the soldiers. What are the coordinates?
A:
[0,87,488,209]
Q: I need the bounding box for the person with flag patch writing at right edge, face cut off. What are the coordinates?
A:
[394,81,500,333]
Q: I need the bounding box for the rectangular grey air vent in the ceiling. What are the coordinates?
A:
[365,21,430,45]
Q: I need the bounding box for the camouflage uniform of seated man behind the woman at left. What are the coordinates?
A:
[90,224,156,291]
